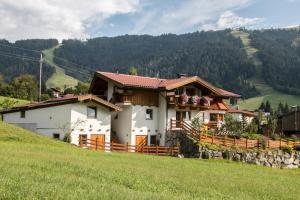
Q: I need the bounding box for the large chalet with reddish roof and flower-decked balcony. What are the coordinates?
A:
[89,72,240,145]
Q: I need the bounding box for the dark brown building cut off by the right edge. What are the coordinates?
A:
[276,107,300,137]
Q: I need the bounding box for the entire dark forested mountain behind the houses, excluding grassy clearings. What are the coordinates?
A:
[0,29,300,98]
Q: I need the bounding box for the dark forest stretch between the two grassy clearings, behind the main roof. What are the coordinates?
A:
[55,30,258,98]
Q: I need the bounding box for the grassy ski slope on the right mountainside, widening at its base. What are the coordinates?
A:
[231,30,300,110]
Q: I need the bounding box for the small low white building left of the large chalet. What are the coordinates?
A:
[1,95,121,145]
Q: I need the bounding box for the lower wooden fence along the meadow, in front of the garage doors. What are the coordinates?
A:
[79,139,179,156]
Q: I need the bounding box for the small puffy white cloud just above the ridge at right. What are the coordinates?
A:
[201,11,263,30]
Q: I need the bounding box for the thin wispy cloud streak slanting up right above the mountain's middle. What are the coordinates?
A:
[132,0,253,34]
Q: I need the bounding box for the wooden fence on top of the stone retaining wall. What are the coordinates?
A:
[200,134,300,149]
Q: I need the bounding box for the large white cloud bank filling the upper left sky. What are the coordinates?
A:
[0,0,139,41]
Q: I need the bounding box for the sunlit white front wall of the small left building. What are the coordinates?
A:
[70,102,111,144]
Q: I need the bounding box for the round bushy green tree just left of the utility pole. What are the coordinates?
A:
[11,74,38,101]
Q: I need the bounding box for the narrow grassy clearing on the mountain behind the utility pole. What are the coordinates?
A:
[43,45,78,89]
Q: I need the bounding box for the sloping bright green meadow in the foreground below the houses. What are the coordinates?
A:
[0,122,300,199]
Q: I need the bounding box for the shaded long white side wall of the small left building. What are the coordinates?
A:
[3,104,71,139]
